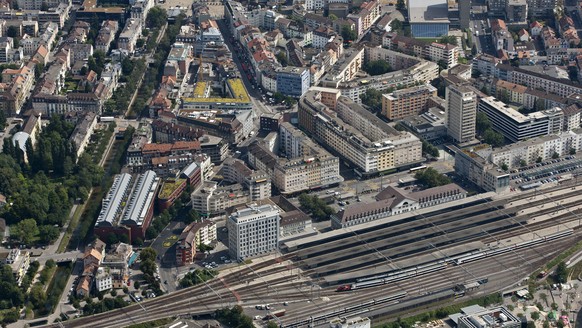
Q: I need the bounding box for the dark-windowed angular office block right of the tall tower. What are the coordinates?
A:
[478,97,564,142]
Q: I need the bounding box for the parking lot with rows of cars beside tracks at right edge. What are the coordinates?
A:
[510,155,582,190]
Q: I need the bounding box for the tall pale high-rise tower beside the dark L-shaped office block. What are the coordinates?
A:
[445,85,477,143]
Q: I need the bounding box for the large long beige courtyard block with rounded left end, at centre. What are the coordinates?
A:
[299,91,422,175]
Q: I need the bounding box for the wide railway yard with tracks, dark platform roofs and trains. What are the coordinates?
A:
[57,182,582,327]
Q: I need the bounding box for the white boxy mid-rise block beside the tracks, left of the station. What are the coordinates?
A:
[226,204,281,260]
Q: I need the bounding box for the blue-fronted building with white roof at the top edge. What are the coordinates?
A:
[406,0,450,38]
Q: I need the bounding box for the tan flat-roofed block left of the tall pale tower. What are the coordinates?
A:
[382,84,437,120]
